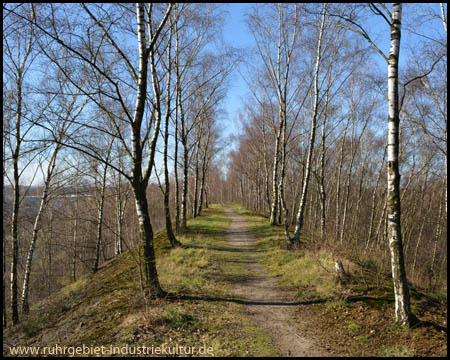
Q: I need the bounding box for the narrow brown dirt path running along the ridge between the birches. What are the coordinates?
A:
[225,209,329,357]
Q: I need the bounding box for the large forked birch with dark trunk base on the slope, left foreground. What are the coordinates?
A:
[16,4,173,297]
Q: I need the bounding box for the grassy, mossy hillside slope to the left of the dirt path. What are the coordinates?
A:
[3,207,277,356]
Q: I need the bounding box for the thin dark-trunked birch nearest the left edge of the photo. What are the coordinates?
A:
[3,2,37,324]
